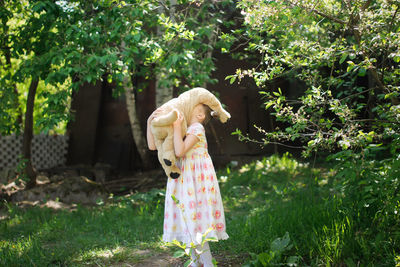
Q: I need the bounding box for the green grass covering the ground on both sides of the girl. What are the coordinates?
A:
[0,155,400,266]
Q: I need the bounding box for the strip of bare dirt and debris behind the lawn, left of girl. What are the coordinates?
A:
[0,165,166,209]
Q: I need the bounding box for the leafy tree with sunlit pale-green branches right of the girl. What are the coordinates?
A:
[227,0,400,158]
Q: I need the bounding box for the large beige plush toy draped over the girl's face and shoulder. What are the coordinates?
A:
[151,87,231,179]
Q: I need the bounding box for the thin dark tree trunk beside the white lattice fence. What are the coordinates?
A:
[22,77,39,188]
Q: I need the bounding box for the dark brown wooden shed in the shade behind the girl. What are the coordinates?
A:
[68,51,291,175]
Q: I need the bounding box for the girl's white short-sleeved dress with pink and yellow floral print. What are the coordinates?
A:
[163,123,229,244]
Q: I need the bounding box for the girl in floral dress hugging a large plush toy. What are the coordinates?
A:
[147,104,228,267]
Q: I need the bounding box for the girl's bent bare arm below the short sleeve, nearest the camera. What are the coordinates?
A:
[174,113,200,158]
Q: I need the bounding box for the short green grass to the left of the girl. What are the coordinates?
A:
[0,191,163,266]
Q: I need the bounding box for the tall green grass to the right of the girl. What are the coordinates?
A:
[214,155,400,266]
